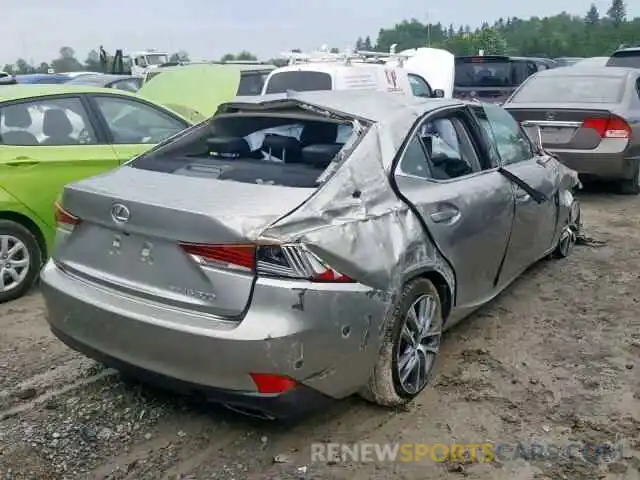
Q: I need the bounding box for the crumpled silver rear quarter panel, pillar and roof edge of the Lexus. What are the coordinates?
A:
[219,92,455,292]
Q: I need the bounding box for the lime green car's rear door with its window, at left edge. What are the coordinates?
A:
[0,95,118,226]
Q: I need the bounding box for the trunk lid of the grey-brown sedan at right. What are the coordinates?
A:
[505,104,612,150]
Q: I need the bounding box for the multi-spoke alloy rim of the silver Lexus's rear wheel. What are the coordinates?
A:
[396,295,442,394]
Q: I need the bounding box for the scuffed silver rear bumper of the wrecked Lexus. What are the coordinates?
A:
[41,260,386,404]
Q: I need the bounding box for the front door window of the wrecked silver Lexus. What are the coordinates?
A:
[480,104,534,165]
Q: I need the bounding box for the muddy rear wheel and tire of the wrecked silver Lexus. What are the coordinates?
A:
[361,278,444,407]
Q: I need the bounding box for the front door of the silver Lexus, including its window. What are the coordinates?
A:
[471,104,560,282]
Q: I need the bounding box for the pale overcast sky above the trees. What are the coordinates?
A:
[0,0,640,65]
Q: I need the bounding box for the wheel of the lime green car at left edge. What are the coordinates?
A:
[0,220,42,303]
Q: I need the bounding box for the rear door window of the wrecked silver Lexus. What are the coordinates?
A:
[400,117,481,180]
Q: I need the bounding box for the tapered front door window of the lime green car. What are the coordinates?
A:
[94,96,187,144]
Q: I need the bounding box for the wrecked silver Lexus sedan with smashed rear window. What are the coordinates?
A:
[42,91,580,418]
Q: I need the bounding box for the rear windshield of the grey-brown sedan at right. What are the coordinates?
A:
[510,75,625,103]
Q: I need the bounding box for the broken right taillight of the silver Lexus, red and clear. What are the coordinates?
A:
[180,243,354,282]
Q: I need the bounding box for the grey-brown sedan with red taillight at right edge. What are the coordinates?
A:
[504,66,640,195]
